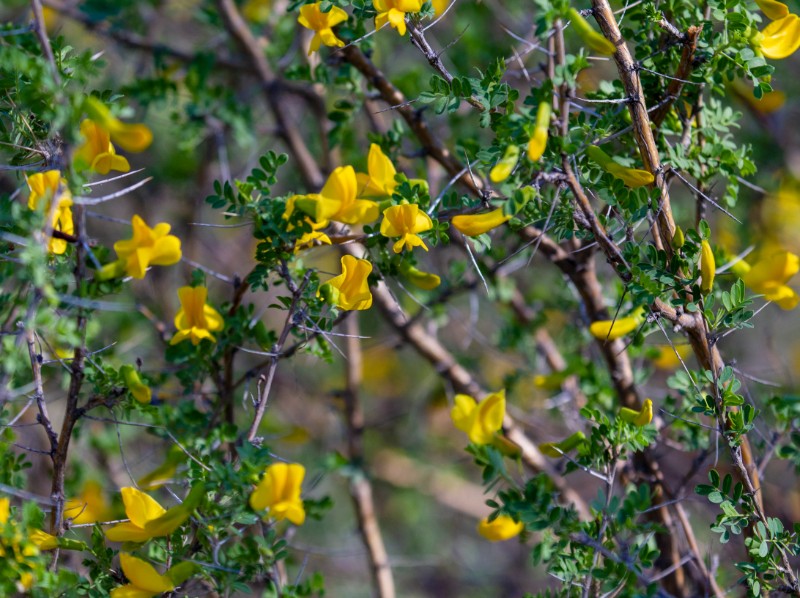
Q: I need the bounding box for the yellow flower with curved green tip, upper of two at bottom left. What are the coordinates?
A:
[106,484,205,542]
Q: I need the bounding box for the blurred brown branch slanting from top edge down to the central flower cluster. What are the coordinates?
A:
[216,0,324,189]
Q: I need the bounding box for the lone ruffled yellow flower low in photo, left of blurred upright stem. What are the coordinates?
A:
[250,463,306,525]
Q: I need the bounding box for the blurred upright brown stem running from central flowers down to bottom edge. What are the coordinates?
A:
[344,314,395,598]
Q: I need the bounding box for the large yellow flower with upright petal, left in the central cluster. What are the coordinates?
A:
[295,166,380,224]
